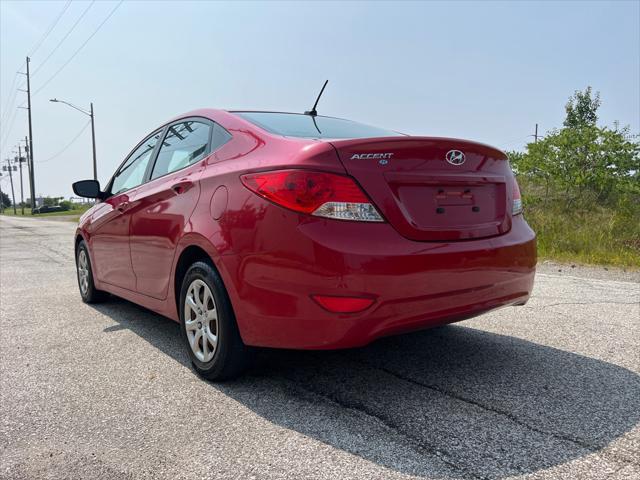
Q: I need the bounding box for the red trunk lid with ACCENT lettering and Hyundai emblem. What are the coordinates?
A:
[331,137,513,241]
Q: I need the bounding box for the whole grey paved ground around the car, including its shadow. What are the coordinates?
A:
[0,217,640,479]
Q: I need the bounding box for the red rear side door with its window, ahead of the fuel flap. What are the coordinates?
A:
[130,118,222,299]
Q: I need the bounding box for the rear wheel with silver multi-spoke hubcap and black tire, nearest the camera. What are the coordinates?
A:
[180,261,253,381]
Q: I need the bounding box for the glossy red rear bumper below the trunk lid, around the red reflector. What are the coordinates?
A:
[222,215,536,349]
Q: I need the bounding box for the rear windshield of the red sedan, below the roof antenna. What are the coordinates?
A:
[233,112,402,138]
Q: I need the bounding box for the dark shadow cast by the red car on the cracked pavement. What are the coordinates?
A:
[95,298,640,478]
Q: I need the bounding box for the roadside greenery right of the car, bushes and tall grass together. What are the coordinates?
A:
[508,88,640,268]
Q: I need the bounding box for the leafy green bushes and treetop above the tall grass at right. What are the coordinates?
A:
[507,87,640,209]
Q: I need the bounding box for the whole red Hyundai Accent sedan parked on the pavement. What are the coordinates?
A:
[73,109,536,380]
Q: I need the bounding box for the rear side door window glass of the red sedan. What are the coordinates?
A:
[151,120,211,179]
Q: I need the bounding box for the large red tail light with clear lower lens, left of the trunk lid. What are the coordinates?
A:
[240,170,384,222]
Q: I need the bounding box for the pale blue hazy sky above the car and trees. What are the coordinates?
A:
[0,0,640,196]
